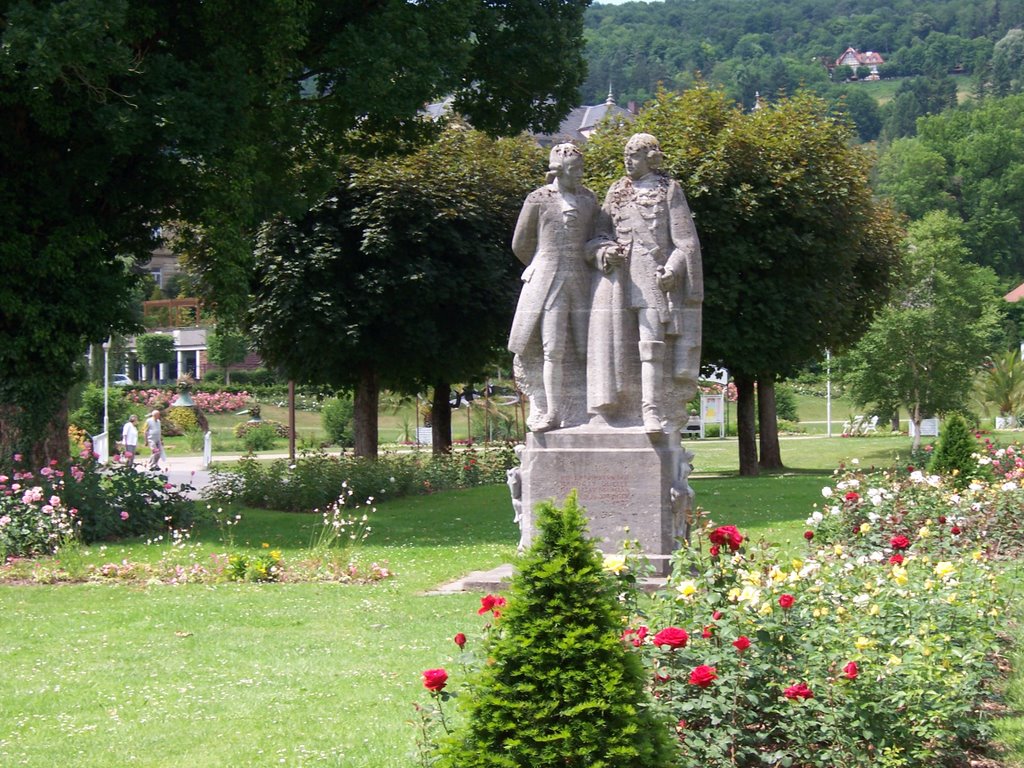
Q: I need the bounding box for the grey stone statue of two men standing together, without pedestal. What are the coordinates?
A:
[509,133,703,434]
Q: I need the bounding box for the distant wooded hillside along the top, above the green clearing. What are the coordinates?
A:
[584,0,1024,106]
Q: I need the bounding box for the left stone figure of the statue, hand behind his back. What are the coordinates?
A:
[508,144,598,432]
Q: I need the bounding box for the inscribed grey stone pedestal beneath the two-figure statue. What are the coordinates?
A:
[521,426,692,570]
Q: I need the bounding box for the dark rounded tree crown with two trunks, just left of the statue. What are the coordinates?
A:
[250,127,544,456]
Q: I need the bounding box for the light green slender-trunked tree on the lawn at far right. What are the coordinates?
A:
[844,212,1000,449]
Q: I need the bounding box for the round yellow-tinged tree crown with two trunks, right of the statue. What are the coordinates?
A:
[588,87,899,475]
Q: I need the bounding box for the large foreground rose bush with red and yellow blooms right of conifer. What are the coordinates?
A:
[626,495,1004,768]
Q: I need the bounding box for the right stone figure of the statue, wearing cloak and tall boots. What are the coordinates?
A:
[587,133,703,433]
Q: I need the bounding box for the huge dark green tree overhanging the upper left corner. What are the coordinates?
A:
[0,0,588,460]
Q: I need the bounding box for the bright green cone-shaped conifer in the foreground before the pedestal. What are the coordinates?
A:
[437,492,675,768]
